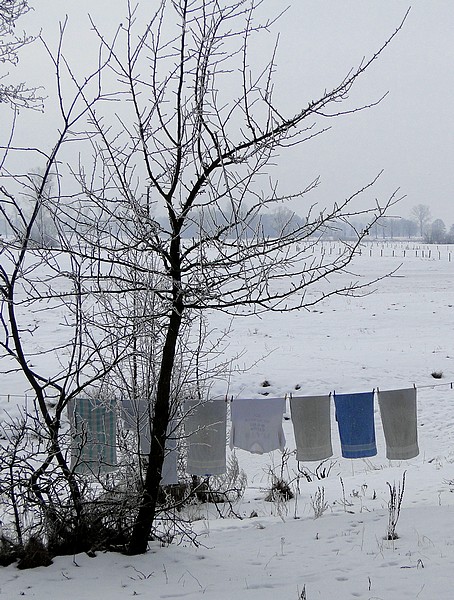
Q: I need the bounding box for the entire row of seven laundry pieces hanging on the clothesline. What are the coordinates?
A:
[65,387,419,485]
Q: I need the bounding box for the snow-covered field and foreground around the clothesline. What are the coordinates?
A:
[0,241,454,600]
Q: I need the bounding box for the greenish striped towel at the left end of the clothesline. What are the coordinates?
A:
[68,398,117,475]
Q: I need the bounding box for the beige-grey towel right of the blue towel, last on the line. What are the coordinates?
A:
[378,388,419,460]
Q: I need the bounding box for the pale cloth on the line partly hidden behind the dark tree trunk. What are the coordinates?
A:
[122,398,179,486]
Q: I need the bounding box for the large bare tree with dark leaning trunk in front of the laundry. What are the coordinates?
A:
[76,0,406,554]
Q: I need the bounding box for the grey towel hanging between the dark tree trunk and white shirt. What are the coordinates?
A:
[185,400,227,476]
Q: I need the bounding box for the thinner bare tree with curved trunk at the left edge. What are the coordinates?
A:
[0,17,133,551]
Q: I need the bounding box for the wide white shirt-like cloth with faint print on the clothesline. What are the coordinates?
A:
[230,398,285,454]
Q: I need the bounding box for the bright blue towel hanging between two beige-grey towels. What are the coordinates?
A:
[334,392,377,458]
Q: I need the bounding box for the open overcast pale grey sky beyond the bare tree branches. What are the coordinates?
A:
[11,0,454,228]
